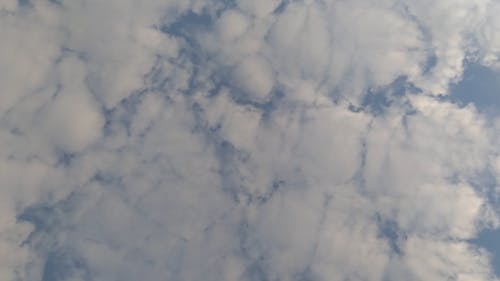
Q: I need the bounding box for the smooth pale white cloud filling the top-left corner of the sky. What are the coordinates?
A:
[0,1,61,116]
